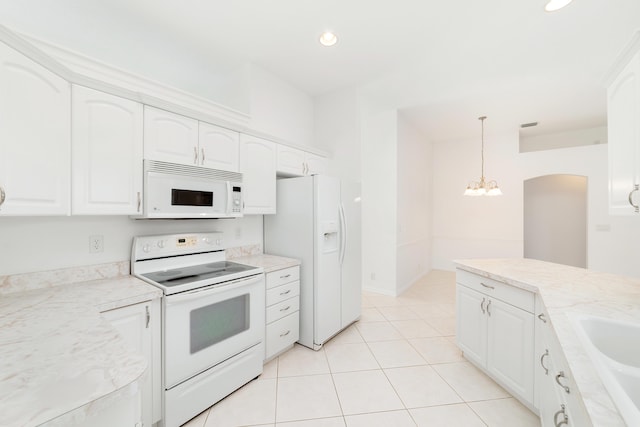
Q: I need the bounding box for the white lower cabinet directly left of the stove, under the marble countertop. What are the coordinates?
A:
[102,299,162,427]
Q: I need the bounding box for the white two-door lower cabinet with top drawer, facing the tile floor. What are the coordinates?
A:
[456,270,534,408]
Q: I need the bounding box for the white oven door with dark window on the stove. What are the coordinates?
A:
[164,274,265,390]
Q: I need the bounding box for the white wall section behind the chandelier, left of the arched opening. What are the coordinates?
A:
[432,133,522,270]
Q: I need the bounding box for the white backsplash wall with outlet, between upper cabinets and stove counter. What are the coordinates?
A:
[0,215,262,276]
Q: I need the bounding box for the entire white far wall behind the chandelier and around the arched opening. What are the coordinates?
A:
[433,133,640,277]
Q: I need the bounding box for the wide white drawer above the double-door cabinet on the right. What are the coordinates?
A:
[456,269,535,313]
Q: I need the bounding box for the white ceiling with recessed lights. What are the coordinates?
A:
[0,0,640,140]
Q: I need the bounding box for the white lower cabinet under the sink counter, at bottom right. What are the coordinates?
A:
[535,298,592,427]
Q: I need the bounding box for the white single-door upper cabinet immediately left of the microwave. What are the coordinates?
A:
[71,85,143,215]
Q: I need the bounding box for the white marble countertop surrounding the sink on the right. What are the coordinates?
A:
[454,259,640,427]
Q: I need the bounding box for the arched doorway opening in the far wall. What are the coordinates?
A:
[524,174,587,268]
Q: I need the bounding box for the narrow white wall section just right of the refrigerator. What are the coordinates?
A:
[361,110,397,295]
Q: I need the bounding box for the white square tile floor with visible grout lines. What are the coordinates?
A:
[180,271,540,427]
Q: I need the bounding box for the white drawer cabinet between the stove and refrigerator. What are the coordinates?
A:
[264,266,300,360]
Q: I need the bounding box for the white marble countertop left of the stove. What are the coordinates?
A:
[0,276,162,426]
